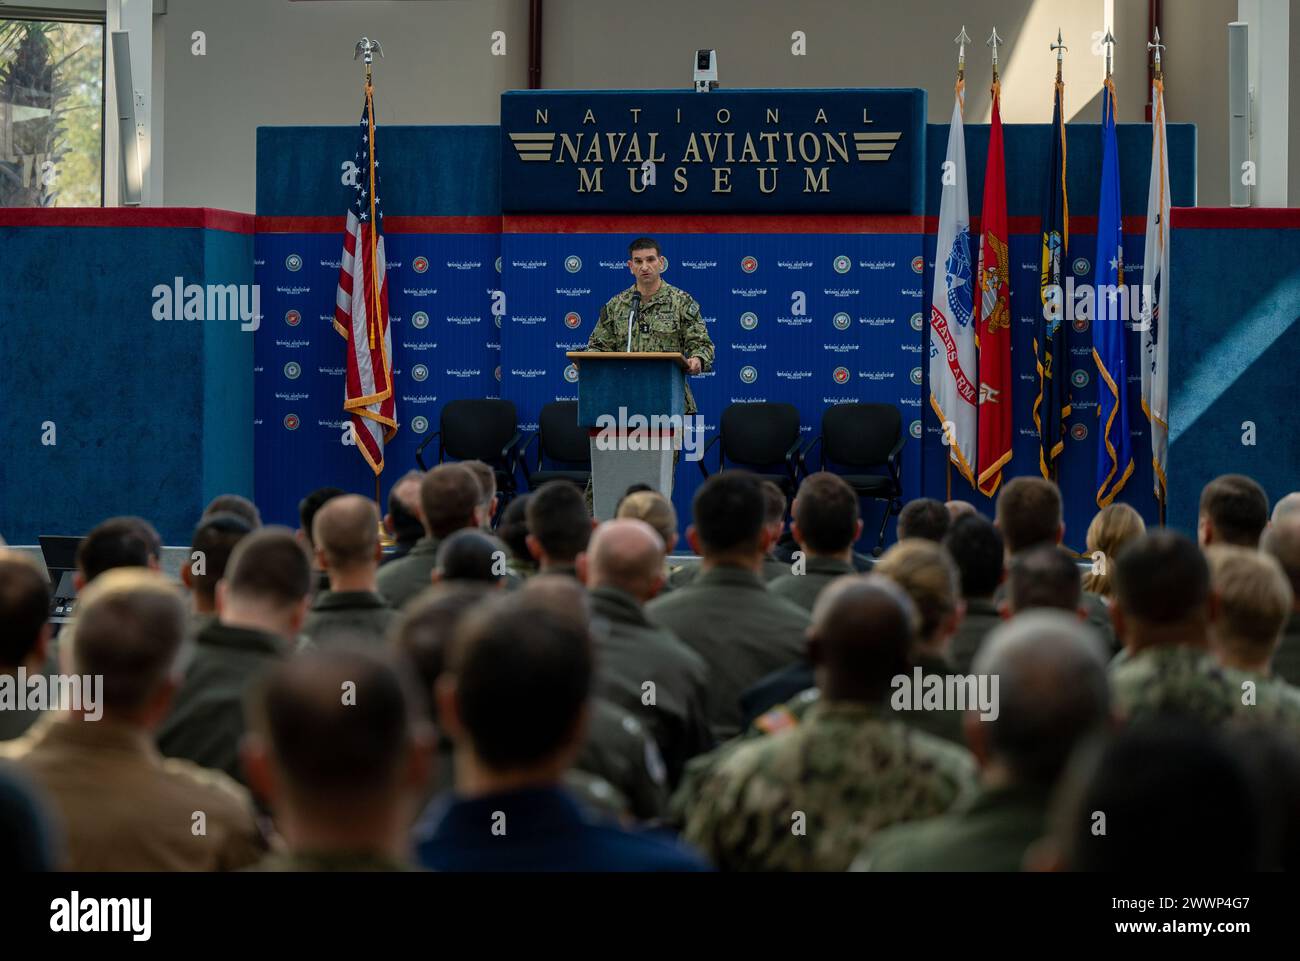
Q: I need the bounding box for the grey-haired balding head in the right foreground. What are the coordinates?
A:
[966,610,1110,785]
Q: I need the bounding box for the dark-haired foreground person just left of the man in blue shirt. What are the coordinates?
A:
[242,647,433,871]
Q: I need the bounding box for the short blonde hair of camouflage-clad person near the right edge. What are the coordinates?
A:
[1205,545,1292,657]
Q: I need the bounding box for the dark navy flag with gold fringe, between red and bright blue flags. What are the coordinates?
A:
[1034,67,1070,480]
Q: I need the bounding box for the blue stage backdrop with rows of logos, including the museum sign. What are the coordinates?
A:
[255,90,1195,547]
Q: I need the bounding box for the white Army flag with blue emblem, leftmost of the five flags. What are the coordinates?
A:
[930,85,978,486]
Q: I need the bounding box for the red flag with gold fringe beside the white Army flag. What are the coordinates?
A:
[976,81,1011,497]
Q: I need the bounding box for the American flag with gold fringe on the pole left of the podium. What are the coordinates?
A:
[334,83,398,476]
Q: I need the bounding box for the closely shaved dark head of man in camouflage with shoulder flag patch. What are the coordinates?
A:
[809,573,919,704]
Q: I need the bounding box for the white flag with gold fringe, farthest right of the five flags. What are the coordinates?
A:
[1141,77,1169,503]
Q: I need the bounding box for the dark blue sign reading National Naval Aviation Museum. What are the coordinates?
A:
[501,90,926,213]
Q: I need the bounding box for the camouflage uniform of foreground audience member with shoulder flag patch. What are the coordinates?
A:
[683,700,975,871]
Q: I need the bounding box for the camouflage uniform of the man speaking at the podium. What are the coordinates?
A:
[586,281,714,414]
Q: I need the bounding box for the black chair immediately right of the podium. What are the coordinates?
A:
[699,403,803,503]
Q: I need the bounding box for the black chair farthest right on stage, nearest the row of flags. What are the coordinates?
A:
[800,403,907,557]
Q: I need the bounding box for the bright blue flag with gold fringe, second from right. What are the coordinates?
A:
[1092,78,1134,507]
